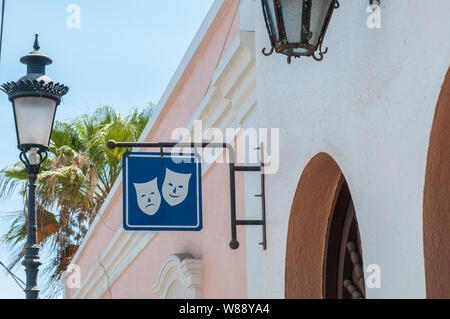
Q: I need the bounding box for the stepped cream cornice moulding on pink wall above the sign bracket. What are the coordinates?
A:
[178,31,257,175]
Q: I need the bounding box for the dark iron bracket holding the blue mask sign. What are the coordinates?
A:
[107,140,267,250]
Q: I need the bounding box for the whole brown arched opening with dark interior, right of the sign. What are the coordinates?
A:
[285,153,365,298]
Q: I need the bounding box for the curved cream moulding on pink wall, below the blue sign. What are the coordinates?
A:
[153,254,202,299]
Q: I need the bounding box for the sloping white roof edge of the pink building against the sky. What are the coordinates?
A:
[70,0,229,264]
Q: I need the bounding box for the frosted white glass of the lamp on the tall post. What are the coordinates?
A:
[14,97,56,147]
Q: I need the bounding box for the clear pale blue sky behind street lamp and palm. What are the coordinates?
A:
[0,0,213,298]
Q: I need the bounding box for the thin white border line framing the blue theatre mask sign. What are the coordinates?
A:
[122,153,201,230]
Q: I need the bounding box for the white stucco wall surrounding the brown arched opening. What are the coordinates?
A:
[245,0,450,298]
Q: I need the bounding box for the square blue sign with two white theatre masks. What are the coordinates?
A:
[123,152,202,231]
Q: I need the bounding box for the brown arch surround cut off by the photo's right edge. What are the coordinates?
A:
[423,70,450,298]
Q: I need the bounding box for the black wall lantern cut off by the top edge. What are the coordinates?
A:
[261,0,339,63]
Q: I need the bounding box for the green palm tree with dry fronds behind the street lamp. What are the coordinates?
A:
[0,104,154,295]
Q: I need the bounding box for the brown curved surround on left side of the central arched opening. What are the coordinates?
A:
[285,153,345,299]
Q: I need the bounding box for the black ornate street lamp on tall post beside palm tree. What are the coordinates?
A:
[2,34,69,299]
